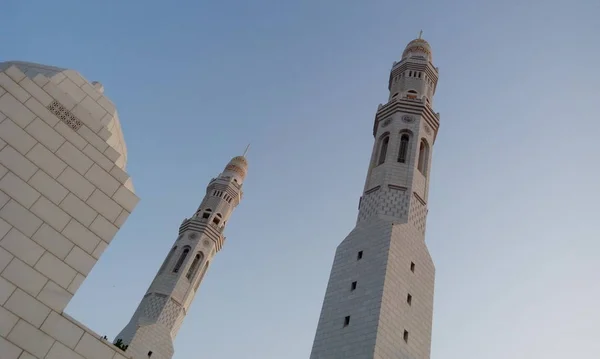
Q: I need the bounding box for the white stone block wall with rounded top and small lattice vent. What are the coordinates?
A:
[0,62,139,359]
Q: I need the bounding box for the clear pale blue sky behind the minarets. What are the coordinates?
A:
[0,0,600,359]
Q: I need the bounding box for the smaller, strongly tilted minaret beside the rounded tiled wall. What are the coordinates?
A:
[115,153,248,359]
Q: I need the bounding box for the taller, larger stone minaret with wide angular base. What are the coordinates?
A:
[310,36,439,359]
